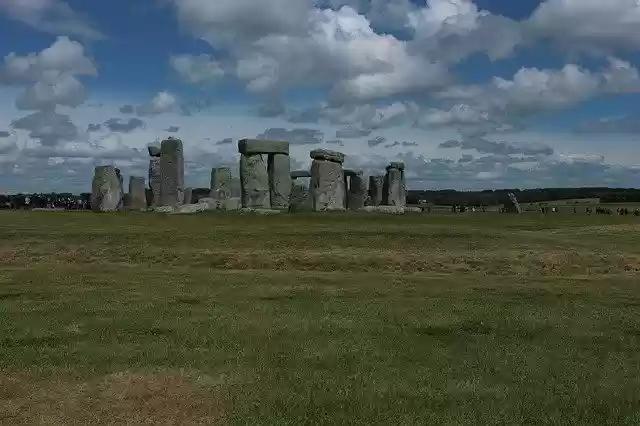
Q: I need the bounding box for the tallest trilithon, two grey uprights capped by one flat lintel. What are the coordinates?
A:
[238,139,291,210]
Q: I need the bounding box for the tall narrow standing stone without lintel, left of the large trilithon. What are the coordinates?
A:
[160,138,184,207]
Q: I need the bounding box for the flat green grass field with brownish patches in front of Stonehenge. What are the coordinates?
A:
[0,212,640,425]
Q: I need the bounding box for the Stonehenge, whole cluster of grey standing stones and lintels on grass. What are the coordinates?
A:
[91,137,410,214]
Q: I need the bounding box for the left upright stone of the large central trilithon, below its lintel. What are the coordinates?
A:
[240,154,271,209]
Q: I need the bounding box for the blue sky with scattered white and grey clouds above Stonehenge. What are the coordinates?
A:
[0,0,640,193]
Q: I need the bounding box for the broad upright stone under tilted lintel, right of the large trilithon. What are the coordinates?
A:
[310,160,346,211]
